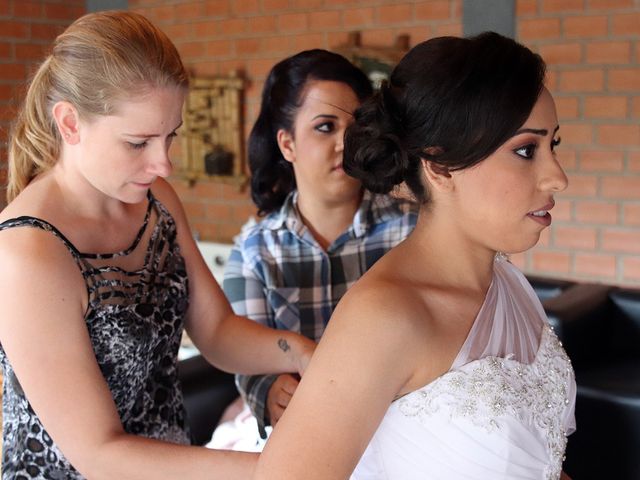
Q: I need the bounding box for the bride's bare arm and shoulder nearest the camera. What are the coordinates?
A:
[254,280,421,480]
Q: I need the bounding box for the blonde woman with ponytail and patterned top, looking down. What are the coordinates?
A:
[0,12,314,480]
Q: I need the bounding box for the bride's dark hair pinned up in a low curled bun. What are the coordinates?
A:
[343,32,545,203]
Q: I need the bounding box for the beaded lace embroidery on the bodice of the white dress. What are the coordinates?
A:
[397,327,575,480]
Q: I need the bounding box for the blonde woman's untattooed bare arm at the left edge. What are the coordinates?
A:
[0,228,256,480]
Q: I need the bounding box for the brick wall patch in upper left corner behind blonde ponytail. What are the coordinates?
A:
[0,0,85,209]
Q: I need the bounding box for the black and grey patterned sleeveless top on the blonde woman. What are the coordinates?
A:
[0,192,190,479]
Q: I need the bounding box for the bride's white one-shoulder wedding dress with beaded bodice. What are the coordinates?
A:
[352,257,576,480]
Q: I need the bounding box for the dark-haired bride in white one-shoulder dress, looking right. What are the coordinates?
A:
[250,33,575,480]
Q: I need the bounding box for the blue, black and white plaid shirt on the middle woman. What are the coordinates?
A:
[223,191,417,438]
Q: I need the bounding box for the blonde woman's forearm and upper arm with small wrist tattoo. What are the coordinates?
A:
[153,179,315,374]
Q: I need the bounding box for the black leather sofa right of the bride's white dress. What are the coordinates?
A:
[530,279,640,480]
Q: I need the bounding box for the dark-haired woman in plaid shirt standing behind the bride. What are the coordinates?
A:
[223,50,417,438]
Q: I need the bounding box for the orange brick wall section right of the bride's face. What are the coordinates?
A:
[514,0,640,285]
